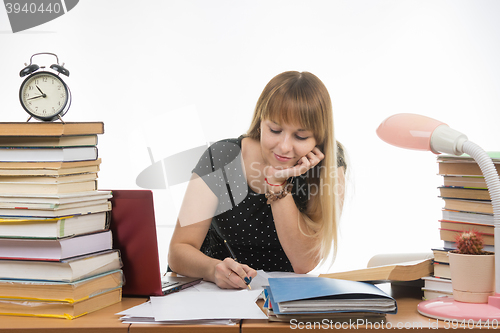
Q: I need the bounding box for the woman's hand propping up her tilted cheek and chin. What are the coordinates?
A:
[266,147,325,184]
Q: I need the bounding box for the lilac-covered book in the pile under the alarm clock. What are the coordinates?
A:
[0,230,113,261]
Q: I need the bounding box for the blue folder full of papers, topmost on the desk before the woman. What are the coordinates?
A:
[269,277,397,314]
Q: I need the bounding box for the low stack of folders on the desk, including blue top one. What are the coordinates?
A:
[264,277,397,324]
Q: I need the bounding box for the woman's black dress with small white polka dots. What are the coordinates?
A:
[193,136,307,272]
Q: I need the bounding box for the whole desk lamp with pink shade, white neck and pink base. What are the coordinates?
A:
[377,113,500,323]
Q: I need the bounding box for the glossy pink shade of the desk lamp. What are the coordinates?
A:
[377,113,446,153]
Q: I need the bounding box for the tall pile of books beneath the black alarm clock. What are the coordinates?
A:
[0,122,123,319]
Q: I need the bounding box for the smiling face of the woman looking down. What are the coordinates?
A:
[260,120,316,169]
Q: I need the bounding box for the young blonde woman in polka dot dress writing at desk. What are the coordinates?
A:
[168,72,347,288]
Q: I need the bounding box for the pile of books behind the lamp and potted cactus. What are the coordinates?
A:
[424,152,500,299]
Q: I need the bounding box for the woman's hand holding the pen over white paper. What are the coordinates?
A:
[214,258,257,289]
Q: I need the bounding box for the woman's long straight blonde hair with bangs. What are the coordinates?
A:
[247,71,340,263]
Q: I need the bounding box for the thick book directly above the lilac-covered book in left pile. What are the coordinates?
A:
[0,211,110,239]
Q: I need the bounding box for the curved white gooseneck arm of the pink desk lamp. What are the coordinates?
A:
[463,141,500,294]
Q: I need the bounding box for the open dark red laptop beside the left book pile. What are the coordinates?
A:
[110,190,201,296]
